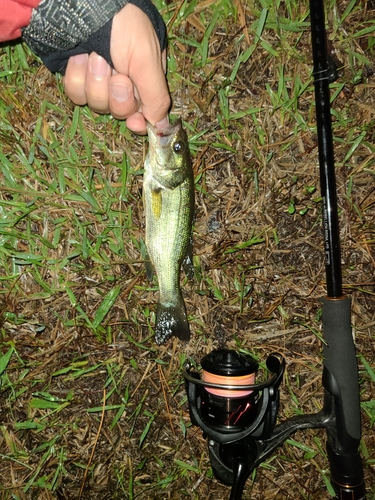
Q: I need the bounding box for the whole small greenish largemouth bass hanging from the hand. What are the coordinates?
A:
[143,121,194,344]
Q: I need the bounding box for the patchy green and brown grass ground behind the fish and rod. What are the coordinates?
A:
[0,0,375,500]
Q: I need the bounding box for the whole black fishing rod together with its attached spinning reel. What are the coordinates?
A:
[183,0,366,500]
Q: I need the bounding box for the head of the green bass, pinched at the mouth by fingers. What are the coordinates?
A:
[145,120,191,189]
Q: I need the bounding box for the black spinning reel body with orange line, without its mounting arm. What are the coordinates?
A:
[184,349,285,499]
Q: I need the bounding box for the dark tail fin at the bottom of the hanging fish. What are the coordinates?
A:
[155,297,190,345]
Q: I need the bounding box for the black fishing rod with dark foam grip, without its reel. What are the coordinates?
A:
[310,0,365,494]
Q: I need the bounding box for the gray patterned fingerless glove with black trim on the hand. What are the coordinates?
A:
[22,0,167,74]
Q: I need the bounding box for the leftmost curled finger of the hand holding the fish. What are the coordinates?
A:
[63,54,89,106]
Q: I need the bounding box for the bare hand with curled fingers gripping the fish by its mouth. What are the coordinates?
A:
[64,4,171,134]
